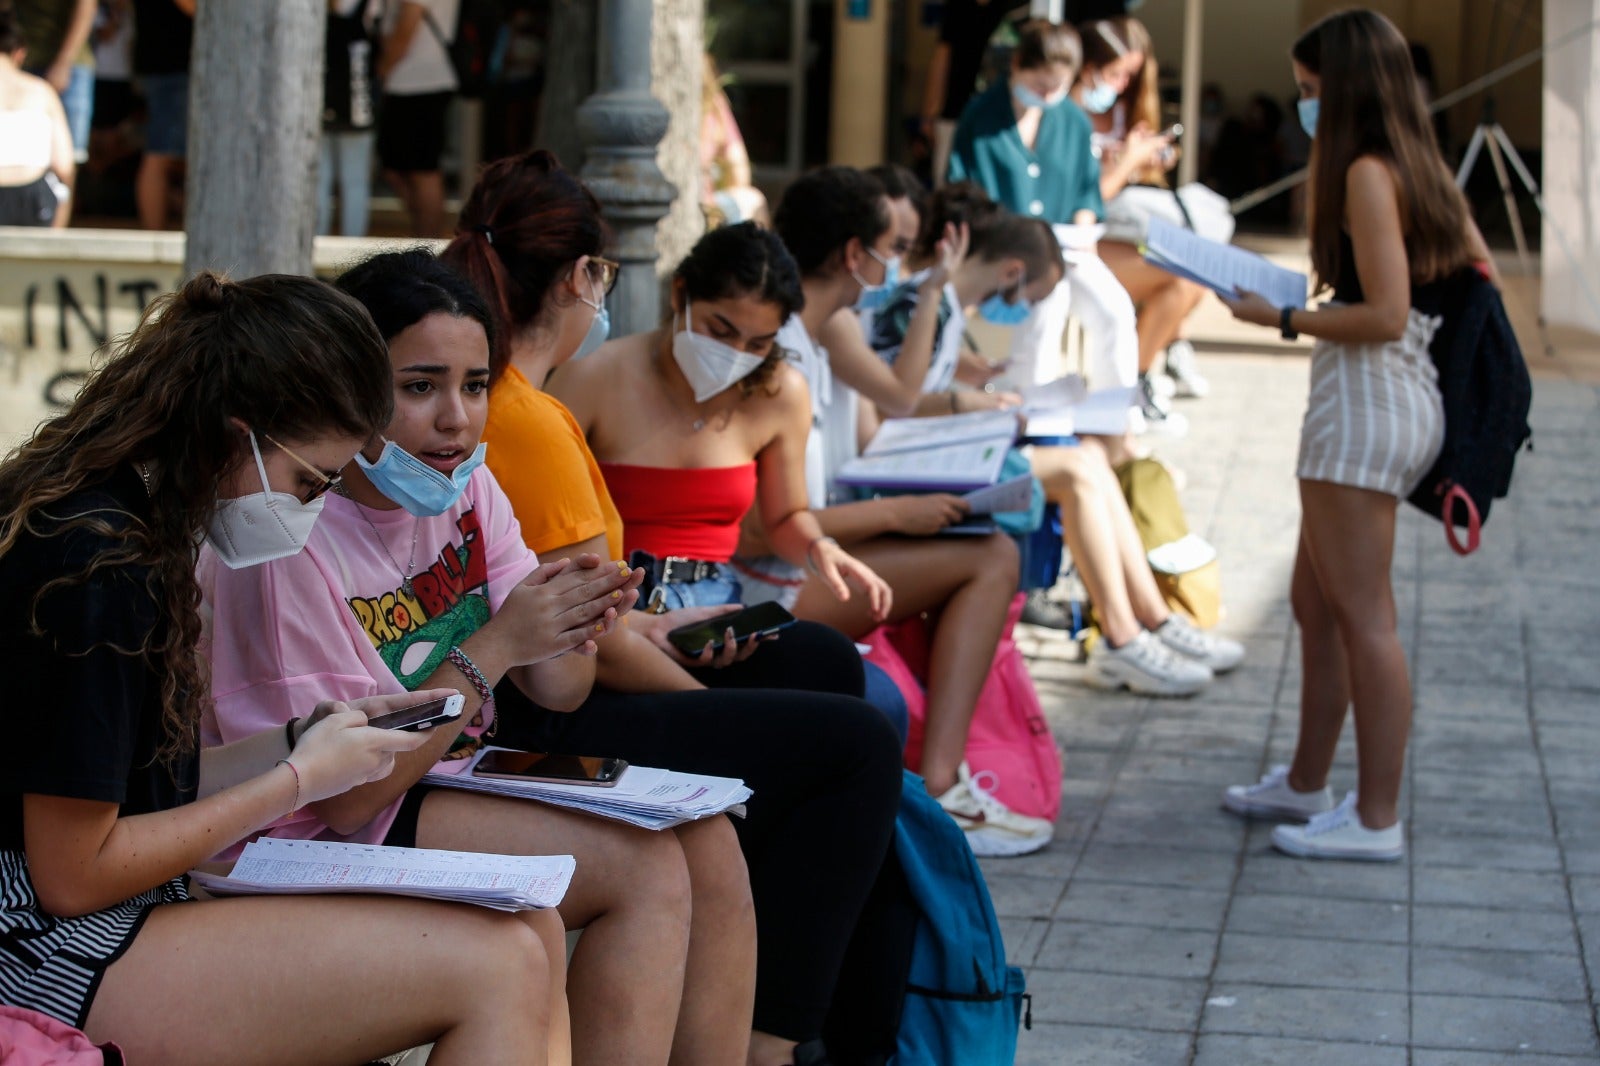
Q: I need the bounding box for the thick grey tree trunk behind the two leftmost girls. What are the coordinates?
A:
[184,0,328,277]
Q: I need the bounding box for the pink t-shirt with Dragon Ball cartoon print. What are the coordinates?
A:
[197,466,538,855]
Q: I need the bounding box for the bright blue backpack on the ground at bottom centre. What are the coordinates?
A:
[893,771,1034,1066]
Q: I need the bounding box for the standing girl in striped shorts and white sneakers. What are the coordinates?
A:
[1222,10,1488,860]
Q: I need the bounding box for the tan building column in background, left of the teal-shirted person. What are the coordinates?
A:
[832,0,891,166]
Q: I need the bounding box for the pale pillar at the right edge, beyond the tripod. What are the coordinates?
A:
[1518,0,1600,333]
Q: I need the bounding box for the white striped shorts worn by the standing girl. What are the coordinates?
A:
[1296,302,1445,499]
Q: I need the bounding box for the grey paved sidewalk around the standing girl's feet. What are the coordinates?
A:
[984,278,1600,1066]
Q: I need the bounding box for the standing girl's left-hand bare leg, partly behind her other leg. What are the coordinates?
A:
[1290,521,1350,792]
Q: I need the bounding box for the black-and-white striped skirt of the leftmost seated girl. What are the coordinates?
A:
[0,852,189,1029]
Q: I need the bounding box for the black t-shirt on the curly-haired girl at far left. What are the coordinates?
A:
[0,467,200,852]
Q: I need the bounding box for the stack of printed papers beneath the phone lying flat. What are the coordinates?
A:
[422,747,752,829]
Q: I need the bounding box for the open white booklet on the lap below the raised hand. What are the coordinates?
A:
[838,411,1018,491]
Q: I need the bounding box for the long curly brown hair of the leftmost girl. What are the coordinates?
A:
[0,274,394,760]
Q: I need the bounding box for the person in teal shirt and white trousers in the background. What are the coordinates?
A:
[947,19,1171,431]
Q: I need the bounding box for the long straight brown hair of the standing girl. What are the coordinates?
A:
[1290,10,1472,290]
